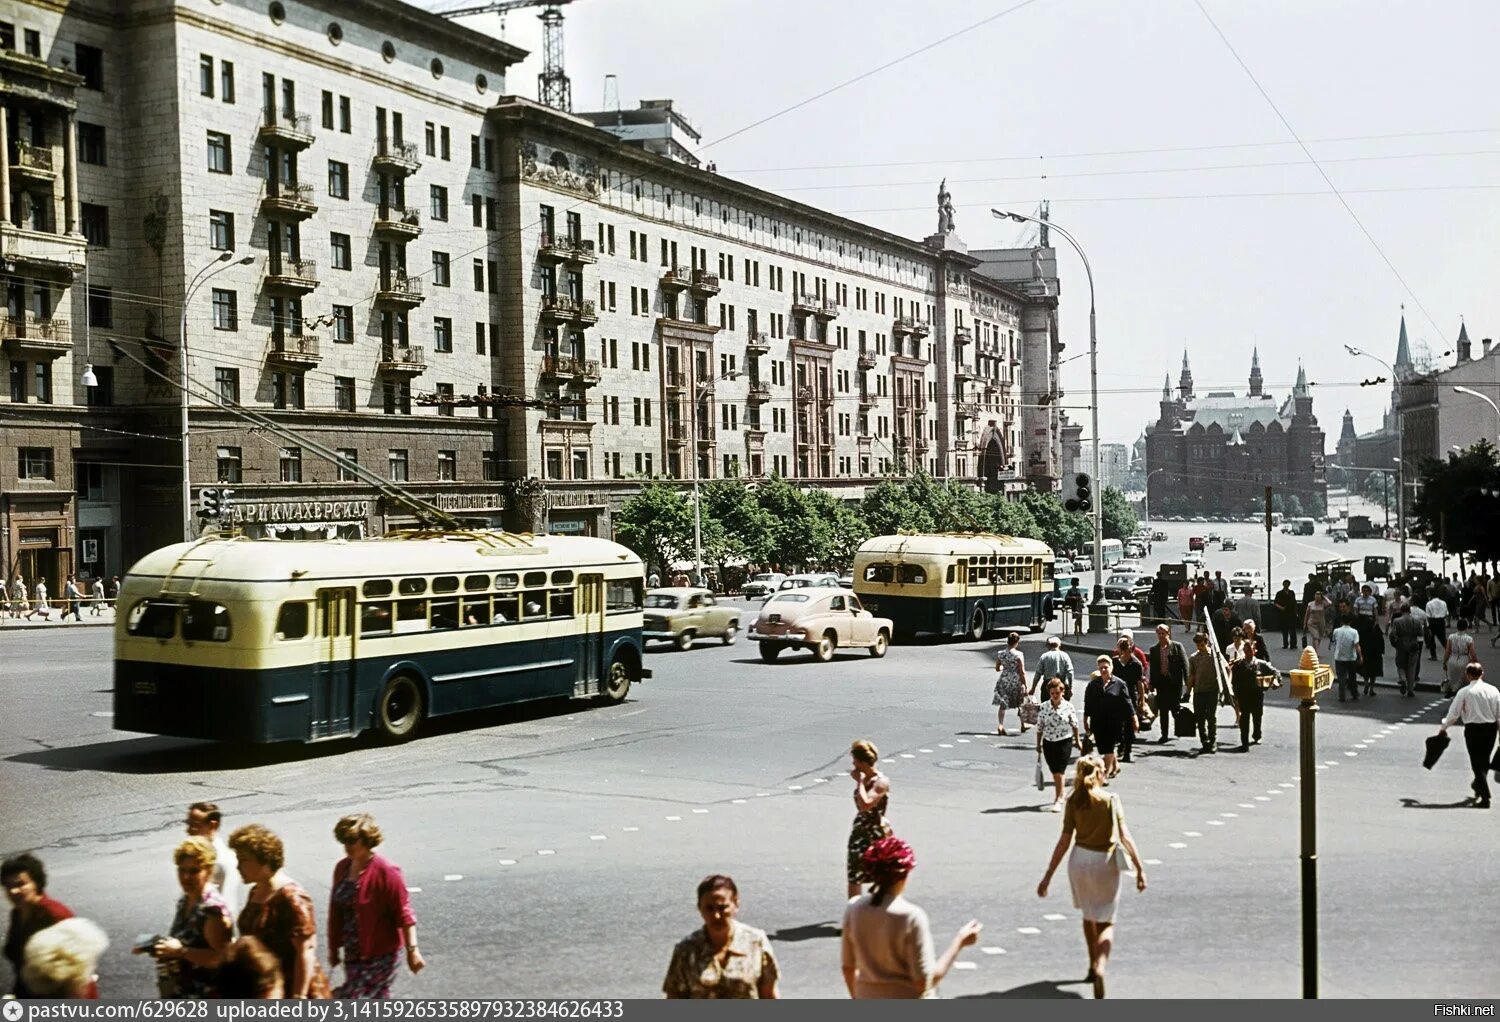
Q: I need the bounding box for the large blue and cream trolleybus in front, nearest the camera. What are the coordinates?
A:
[114,531,650,741]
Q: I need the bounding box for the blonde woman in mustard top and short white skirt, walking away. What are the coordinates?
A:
[1037,758,1146,998]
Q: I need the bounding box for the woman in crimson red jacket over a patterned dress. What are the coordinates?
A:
[329,813,426,998]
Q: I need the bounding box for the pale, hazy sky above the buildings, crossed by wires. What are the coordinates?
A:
[417,0,1500,452]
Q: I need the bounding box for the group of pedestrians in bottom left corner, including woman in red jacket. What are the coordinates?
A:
[0,801,426,998]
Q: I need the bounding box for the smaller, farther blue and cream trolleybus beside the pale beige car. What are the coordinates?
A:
[854,533,1056,639]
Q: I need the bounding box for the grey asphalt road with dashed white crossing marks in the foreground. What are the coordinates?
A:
[0,615,1500,998]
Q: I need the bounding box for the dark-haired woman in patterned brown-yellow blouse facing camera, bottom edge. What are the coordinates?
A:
[662,873,782,999]
